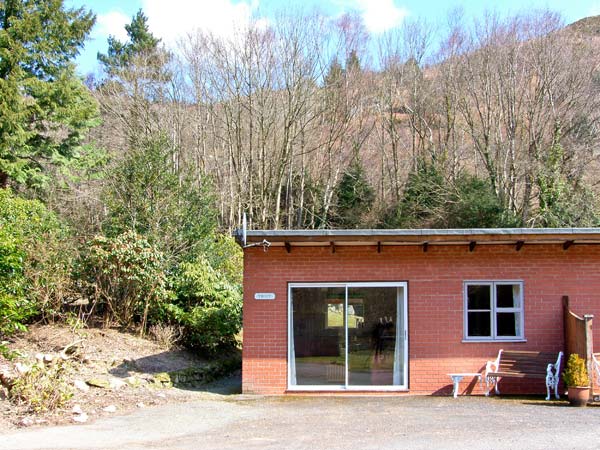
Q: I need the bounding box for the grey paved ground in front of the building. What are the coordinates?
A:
[0,394,600,450]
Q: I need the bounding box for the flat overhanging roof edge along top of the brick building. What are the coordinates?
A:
[235,228,600,251]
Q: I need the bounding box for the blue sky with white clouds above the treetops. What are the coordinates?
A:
[65,0,600,74]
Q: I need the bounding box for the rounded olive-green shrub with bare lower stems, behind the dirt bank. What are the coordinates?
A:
[86,231,169,330]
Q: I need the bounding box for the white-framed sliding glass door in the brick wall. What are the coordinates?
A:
[289,283,407,390]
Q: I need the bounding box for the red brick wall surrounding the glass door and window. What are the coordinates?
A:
[242,244,600,394]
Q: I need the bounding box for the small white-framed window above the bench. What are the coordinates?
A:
[464,281,524,341]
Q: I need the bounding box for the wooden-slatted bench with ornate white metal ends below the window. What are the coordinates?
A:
[484,350,563,400]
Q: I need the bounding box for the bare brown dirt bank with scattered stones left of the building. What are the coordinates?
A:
[0,325,240,428]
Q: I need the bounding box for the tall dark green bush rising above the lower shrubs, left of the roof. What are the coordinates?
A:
[104,137,216,264]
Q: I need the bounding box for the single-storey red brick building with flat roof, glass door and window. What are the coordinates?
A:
[242,228,600,394]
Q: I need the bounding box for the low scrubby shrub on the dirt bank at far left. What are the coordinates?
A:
[9,359,73,413]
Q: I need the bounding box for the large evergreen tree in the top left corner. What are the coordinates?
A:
[0,0,97,187]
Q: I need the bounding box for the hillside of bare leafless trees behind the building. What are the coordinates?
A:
[82,11,600,229]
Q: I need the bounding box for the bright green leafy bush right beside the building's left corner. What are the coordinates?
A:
[165,251,242,353]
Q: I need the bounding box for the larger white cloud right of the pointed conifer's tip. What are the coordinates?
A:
[142,0,258,44]
